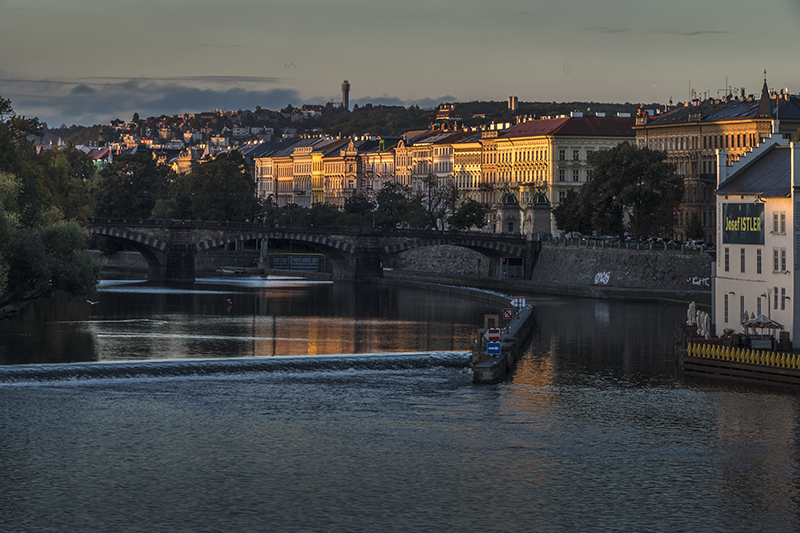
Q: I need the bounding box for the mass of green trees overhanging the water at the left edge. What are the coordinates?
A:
[0,97,100,316]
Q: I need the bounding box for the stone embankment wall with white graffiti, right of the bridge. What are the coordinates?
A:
[532,244,712,291]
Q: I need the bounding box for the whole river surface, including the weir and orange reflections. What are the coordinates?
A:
[0,279,800,532]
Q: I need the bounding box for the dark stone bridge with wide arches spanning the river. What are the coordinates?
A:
[89,218,539,281]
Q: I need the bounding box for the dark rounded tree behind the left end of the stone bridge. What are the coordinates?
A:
[94,154,173,218]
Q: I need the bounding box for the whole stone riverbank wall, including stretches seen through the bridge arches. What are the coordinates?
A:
[91,243,713,299]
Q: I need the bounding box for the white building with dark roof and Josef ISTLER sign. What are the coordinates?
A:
[712,135,800,348]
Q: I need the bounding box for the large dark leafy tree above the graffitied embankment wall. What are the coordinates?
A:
[554,143,682,237]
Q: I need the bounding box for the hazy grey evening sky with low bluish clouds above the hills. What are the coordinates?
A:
[0,0,800,127]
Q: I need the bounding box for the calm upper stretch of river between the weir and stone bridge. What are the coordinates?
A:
[0,278,490,364]
